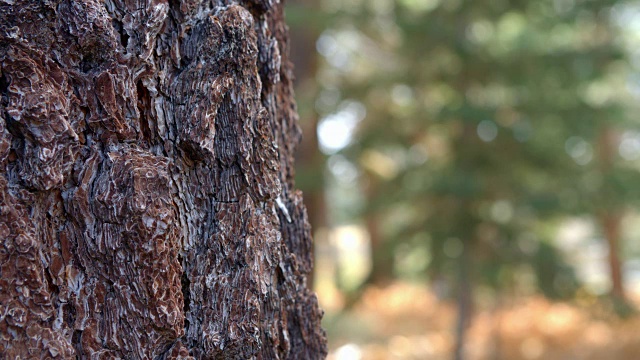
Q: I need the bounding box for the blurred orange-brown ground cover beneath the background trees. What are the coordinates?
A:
[320,282,640,360]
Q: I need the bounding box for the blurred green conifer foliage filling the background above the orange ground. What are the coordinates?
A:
[294,0,640,297]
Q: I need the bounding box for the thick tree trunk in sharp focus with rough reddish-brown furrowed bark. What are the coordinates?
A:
[0,0,326,359]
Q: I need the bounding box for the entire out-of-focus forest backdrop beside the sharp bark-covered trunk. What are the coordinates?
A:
[287,0,640,360]
